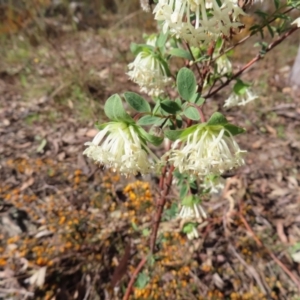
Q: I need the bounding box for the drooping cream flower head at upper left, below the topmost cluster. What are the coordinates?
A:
[127,51,172,97]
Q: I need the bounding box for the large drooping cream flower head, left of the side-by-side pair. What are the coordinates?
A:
[83,122,158,175]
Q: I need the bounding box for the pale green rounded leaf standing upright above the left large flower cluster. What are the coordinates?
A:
[104,94,134,123]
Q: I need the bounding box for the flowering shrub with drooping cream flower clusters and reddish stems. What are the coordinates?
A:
[84,0,300,299]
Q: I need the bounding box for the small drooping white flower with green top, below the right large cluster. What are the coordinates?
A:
[178,196,207,221]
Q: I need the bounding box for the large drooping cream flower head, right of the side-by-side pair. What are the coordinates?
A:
[167,124,245,178]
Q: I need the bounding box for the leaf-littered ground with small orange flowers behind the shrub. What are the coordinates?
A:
[0,2,300,300]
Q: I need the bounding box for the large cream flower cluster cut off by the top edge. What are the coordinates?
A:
[153,0,244,47]
